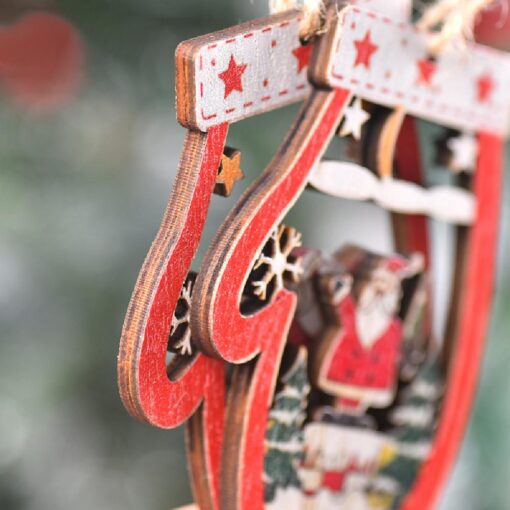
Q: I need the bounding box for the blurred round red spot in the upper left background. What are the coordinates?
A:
[0,13,84,113]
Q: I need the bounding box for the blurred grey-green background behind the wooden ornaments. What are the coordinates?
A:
[0,0,510,510]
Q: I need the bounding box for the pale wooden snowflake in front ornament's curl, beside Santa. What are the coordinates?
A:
[252,225,303,301]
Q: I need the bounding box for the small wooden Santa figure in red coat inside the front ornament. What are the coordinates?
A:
[314,246,423,414]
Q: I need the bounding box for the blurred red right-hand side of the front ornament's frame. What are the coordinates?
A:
[402,133,503,510]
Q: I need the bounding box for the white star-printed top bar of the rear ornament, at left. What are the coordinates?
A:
[176,10,312,131]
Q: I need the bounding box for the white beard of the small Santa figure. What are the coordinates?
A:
[356,295,397,349]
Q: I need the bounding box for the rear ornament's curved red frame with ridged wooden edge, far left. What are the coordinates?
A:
[118,125,228,509]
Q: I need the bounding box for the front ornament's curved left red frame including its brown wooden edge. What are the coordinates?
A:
[192,90,350,510]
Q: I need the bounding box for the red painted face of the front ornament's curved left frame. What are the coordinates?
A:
[192,89,350,510]
